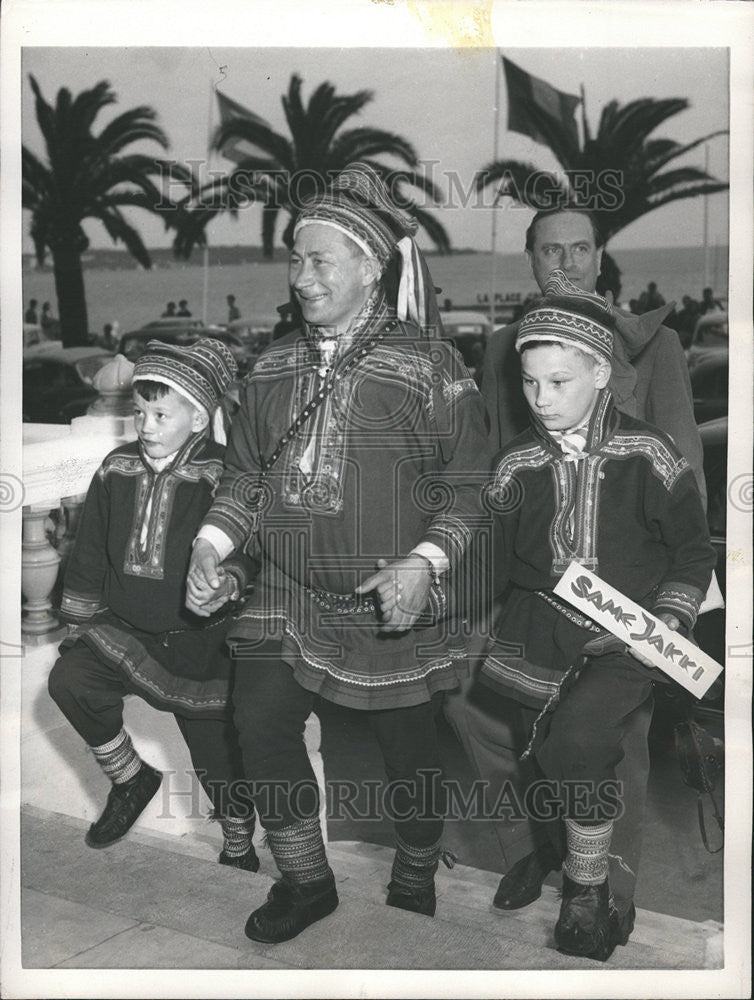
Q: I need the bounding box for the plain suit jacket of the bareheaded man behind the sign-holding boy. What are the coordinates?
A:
[481,303,707,505]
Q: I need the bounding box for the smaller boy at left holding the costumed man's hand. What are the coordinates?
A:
[49,339,259,871]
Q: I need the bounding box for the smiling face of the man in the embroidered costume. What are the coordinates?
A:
[288,223,379,334]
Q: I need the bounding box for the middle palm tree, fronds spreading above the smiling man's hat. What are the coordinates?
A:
[174,73,450,258]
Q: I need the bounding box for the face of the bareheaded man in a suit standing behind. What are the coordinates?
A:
[529,212,602,292]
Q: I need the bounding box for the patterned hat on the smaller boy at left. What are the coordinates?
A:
[133,337,238,443]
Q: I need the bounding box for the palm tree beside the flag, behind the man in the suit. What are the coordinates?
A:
[475,97,728,297]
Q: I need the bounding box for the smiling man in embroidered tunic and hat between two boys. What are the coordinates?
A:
[188,164,490,942]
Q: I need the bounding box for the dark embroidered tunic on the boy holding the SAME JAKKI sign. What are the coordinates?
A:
[482,390,715,707]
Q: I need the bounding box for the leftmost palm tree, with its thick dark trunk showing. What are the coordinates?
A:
[22,76,192,347]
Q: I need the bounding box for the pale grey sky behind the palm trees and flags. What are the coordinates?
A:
[21,46,728,252]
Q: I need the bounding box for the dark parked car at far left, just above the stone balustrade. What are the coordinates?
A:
[22,341,113,424]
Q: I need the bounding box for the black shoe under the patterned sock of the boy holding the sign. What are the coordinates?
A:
[555,872,612,962]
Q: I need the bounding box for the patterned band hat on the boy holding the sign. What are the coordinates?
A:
[516,270,615,362]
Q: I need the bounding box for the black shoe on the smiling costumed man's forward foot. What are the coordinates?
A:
[244,872,338,944]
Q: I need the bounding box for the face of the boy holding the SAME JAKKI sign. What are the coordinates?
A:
[521,344,610,431]
